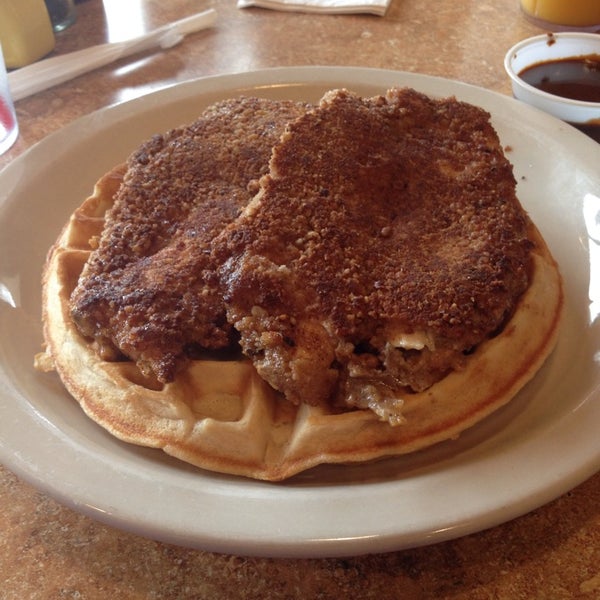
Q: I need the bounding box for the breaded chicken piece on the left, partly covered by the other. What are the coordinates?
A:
[71,98,306,382]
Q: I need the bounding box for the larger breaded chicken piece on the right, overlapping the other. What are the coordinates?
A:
[214,89,531,421]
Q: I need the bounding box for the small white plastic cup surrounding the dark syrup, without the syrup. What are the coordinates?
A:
[504,32,600,124]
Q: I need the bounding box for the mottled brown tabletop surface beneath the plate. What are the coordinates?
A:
[0,0,600,600]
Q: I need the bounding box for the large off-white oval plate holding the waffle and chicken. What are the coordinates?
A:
[0,67,600,556]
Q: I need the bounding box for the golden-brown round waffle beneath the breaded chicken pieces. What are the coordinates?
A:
[36,166,563,480]
